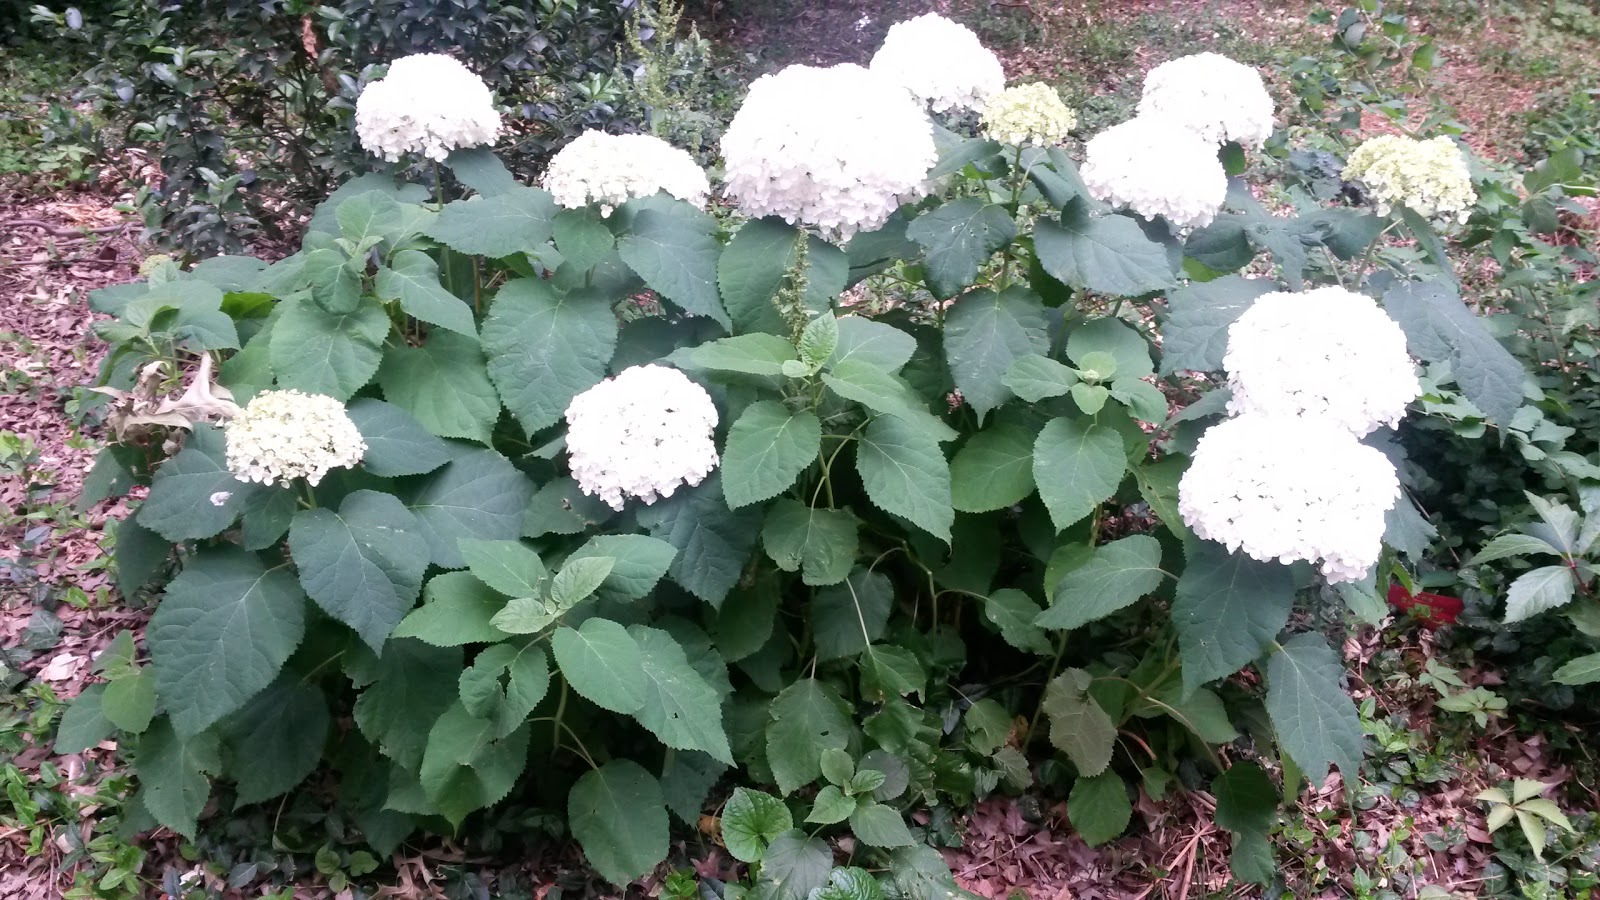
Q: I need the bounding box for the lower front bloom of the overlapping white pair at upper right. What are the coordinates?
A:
[1082,115,1227,231]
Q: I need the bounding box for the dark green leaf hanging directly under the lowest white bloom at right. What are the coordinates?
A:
[1173,541,1294,692]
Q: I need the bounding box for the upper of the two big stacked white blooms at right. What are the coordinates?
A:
[1222,287,1422,436]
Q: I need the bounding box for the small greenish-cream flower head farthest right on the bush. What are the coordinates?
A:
[1344,135,1478,221]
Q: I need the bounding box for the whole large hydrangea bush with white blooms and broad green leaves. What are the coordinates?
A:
[62,24,1523,898]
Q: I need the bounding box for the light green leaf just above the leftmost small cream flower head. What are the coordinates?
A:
[267,299,390,400]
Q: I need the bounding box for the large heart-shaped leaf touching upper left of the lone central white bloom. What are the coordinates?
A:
[483,279,616,436]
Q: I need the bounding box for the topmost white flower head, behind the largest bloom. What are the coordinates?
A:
[872,13,1005,112]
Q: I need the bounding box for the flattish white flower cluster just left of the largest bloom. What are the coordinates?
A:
[541,131,710,216]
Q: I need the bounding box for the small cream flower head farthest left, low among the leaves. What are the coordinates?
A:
[226,391,366,485]
